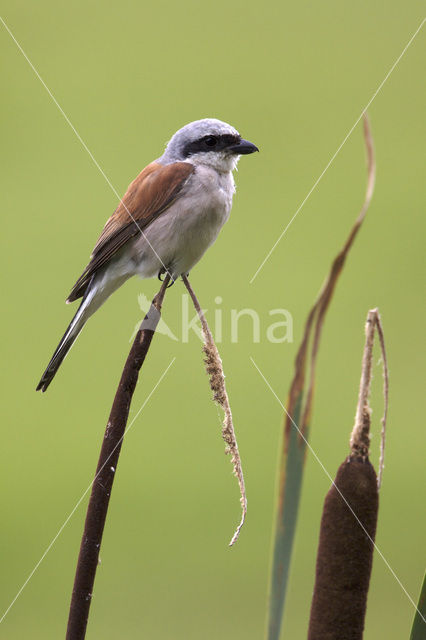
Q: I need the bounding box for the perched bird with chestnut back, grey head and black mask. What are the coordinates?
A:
[36,118,259,392]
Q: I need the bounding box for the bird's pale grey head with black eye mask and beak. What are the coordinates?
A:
[159,118,259,171]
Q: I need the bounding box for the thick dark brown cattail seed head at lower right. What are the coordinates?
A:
[308,456,379,640]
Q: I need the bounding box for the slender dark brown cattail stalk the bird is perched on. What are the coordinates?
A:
[66,274,170,640]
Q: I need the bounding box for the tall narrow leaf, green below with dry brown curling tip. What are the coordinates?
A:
[266,114,376,640]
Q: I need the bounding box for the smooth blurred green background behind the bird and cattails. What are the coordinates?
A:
[0,0,426,640]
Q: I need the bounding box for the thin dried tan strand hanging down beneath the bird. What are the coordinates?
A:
[182,276,247,547]
